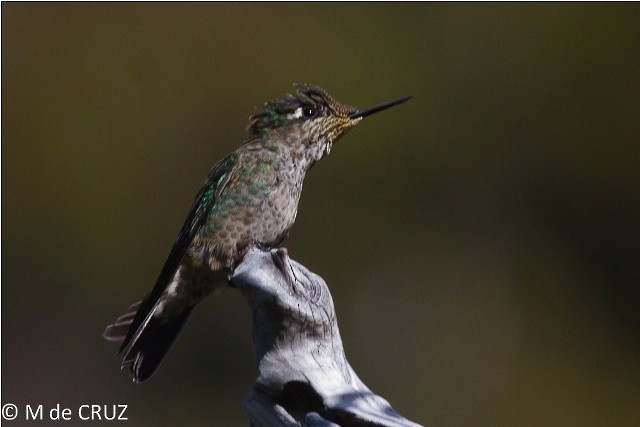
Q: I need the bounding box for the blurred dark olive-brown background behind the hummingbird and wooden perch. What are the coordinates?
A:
[2,3,640,426]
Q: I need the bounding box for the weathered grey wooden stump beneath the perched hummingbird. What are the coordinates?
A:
[231,249,418,427]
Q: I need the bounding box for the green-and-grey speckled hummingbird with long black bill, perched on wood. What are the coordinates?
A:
[103,86,411,383]
